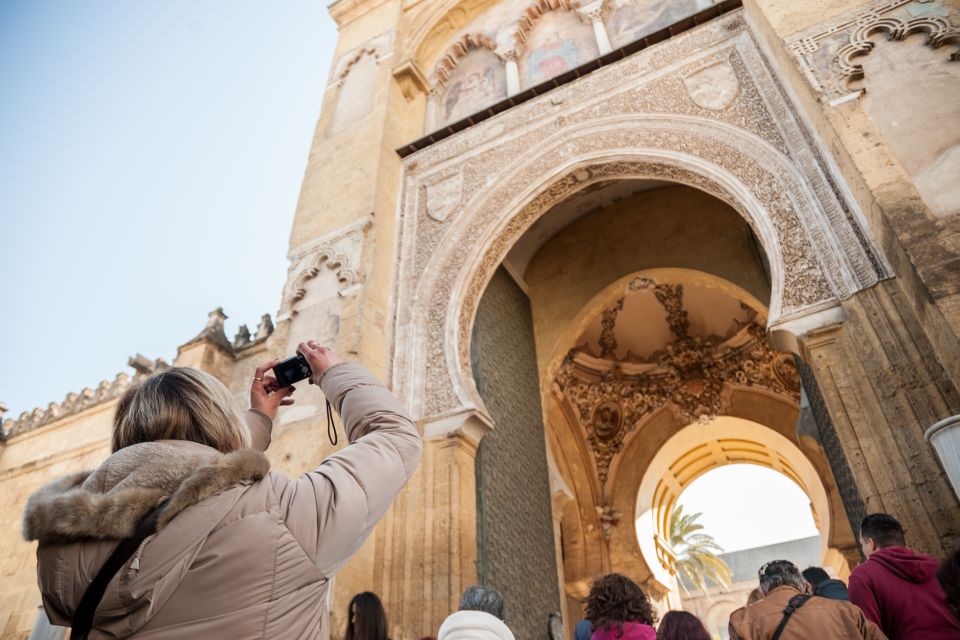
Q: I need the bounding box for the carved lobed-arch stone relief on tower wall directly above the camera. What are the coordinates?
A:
[281,216,373,310]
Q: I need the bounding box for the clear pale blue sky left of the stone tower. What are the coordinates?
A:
[0,0,336,418]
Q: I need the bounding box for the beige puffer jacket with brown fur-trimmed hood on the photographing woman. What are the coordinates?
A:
[24,364,421,640]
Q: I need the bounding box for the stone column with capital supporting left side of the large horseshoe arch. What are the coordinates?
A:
[373,411,490,638]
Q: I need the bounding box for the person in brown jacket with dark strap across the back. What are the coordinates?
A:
[729,560,886,640]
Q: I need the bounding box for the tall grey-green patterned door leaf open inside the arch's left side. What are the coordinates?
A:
[473,268,560,640]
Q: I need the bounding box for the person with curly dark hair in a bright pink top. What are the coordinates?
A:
[587,573,657,640]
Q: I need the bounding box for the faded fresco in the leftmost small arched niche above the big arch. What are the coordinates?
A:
[440,49,507,124]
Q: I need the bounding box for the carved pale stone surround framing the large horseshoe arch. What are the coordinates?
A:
[392,11,887,419]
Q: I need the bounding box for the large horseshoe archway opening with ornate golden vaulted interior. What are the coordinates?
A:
[471,180,852,636]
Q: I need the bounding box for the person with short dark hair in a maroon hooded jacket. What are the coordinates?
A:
[849,513,960,640]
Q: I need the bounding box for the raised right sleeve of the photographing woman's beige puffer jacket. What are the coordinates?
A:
[275,363,422,577]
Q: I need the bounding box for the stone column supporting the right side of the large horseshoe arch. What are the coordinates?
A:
[801,281,960,556]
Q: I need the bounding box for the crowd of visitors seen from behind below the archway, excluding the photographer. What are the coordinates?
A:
[344,513,960,640]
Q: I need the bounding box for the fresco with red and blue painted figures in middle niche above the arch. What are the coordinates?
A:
[520,11,599,88]
